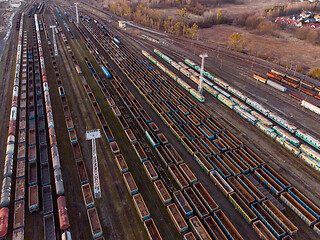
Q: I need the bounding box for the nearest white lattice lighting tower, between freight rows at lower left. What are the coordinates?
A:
[86,129,101,198]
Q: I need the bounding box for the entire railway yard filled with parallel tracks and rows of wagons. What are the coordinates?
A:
[0,0,320,240]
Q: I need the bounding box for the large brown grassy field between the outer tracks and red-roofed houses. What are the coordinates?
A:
[200,25,320,68]
